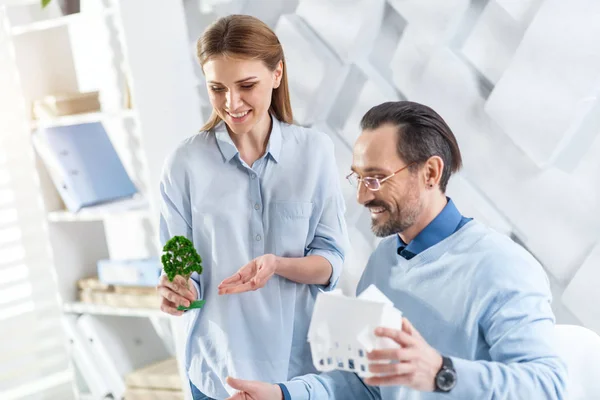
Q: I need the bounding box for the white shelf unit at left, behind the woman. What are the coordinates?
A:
[0,0,202,400]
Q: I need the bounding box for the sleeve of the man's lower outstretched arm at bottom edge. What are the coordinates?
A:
[279,371,381,400]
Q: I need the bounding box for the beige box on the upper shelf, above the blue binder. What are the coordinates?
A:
[33,91,102,120]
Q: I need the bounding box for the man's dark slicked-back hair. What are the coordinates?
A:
[360,101,462,193]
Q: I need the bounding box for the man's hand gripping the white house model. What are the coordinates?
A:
[364,318,442,392]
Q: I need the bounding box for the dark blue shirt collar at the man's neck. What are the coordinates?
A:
[396,197,462,255]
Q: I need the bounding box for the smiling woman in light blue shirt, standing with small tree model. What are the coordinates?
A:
[158,15,347,399]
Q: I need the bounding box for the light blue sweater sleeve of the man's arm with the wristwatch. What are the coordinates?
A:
[447,255,566,399]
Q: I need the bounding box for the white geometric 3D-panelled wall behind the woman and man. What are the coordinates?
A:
[188,0,600,329]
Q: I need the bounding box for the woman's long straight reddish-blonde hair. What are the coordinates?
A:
[197,15,293,131]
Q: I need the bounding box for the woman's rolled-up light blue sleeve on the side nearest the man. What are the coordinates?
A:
[306,137,348,290]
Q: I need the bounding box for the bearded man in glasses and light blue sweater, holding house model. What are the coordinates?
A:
[223,102,566,400]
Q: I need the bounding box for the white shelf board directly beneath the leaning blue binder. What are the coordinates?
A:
[48,197,150,222]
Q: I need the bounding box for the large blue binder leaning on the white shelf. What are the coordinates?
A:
[33,122,137,212]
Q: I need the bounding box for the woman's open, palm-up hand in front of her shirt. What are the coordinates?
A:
[217,254,277,294]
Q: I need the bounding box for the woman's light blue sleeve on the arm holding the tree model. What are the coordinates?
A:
[159,153,203,300]
